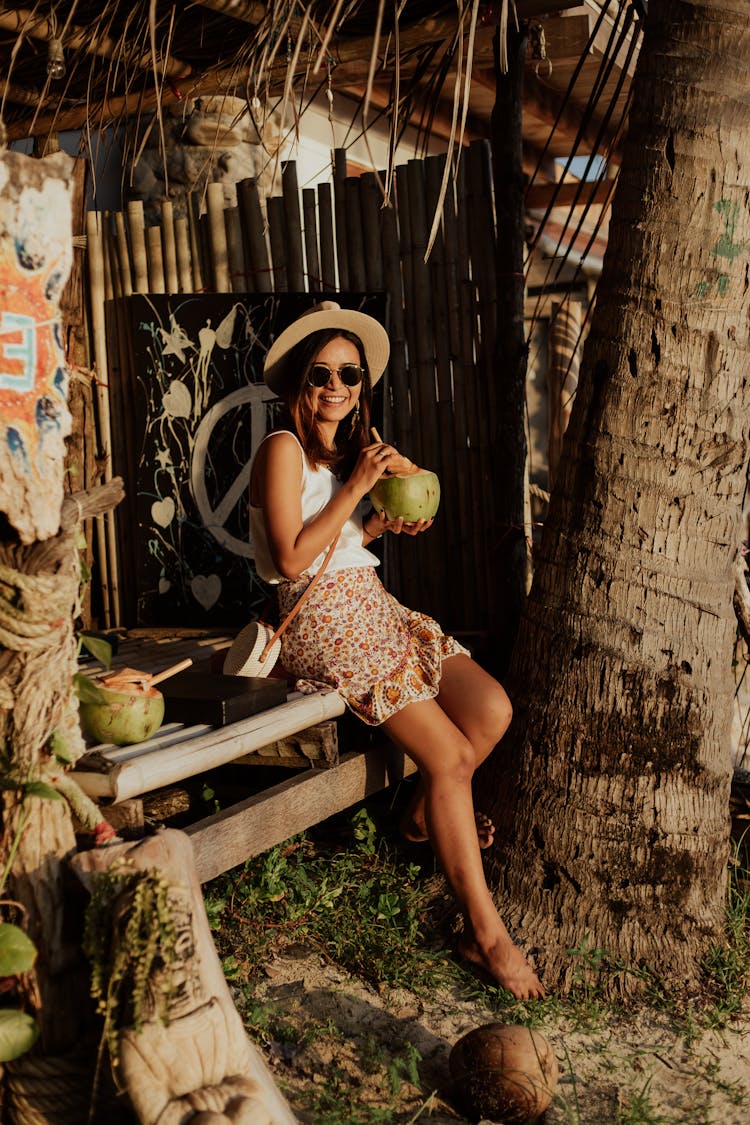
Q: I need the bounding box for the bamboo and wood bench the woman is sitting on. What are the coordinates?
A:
[74,630,415,882]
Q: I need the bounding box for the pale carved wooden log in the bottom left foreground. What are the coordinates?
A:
[72,829,295,1125]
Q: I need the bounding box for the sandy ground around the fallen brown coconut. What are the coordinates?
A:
[251,945,750,1125]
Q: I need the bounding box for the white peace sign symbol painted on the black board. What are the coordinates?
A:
[190,383,275,558]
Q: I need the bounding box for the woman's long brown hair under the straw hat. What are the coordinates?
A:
[278,329,372,479]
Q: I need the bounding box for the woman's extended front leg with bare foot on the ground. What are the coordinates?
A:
[383,700,544,999]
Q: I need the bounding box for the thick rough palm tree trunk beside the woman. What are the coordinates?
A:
[483,0,750,993]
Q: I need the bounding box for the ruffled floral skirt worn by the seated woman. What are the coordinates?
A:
[279,566,469,726]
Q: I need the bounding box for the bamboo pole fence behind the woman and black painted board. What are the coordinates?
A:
[89,141,498,635]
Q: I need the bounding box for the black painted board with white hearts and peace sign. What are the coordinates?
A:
[118,294,385,627]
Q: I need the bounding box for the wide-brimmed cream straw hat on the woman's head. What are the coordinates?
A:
[263,300,390,395]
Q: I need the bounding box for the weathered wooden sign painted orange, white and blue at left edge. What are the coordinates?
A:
[0,151,74,543]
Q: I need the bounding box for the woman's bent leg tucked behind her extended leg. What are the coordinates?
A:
[401,654,513,848]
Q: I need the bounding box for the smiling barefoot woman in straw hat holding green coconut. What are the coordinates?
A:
[250,302,544,999]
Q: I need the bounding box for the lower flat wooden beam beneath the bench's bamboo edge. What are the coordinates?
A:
[184,744,416,883]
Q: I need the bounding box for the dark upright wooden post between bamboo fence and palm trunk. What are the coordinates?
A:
[489,23,528,672]
